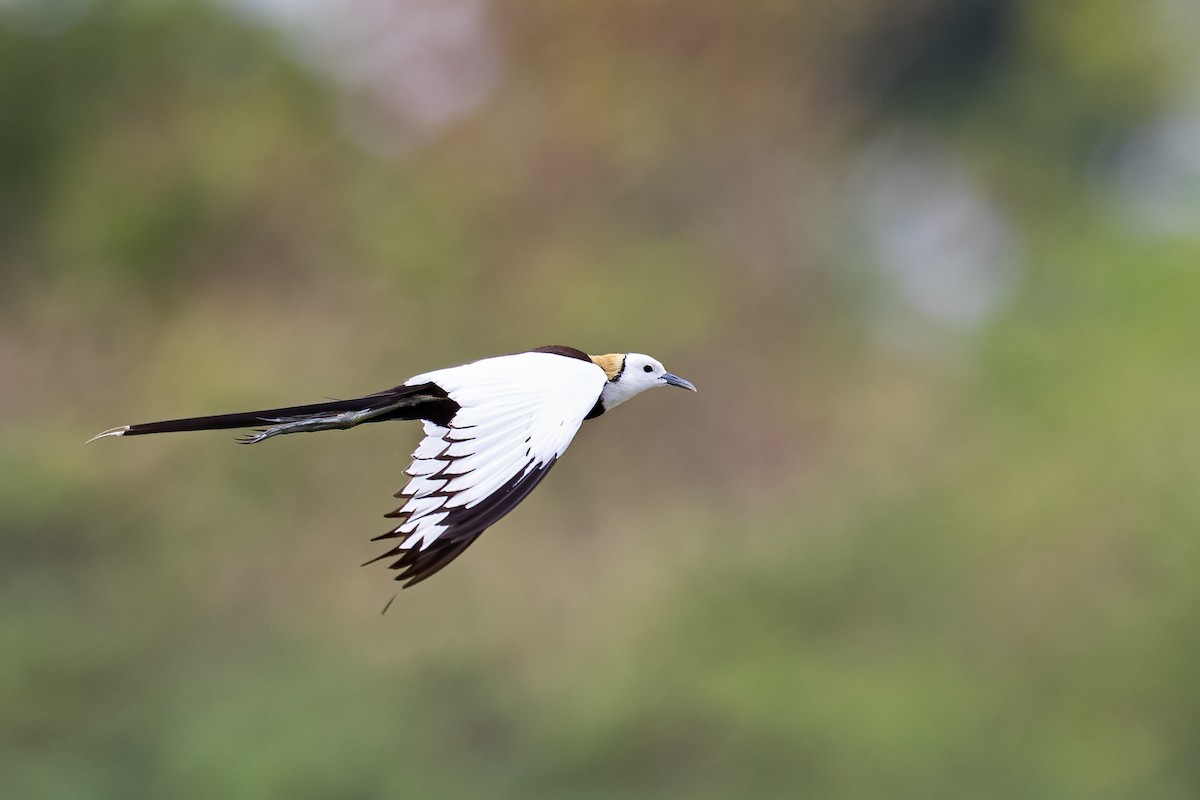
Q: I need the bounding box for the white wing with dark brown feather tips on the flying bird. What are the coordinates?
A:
[368,353,606,588]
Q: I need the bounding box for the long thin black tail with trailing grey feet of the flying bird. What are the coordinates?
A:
[95,383,458,439]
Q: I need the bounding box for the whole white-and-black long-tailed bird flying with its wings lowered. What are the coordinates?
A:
[92,345,696,588]
